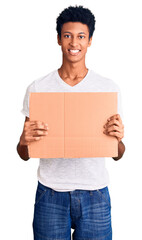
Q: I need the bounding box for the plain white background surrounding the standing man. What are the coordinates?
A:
[0,0,142,240]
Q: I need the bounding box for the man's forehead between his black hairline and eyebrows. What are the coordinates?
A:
[62,22,89,34]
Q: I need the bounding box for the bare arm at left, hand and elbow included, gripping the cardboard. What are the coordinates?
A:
[17,117,49,161]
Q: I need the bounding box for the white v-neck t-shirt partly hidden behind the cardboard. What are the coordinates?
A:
[21,70,122,192]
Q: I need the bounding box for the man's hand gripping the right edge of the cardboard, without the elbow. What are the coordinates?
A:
[103,114,124,143]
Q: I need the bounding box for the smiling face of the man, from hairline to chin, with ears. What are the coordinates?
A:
[58,22,92,62]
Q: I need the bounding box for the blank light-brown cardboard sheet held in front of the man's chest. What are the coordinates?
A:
[28,92,118,158]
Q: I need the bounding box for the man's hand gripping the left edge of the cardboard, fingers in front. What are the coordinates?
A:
[19,118,49,146]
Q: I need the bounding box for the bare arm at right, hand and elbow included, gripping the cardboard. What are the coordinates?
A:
[104,114,125,161]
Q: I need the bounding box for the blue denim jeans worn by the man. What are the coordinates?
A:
[33,182,112,240]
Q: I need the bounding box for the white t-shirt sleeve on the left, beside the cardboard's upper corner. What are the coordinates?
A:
[21,82,36,117]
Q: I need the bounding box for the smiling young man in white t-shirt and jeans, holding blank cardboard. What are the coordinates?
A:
[17,6,125,240]
